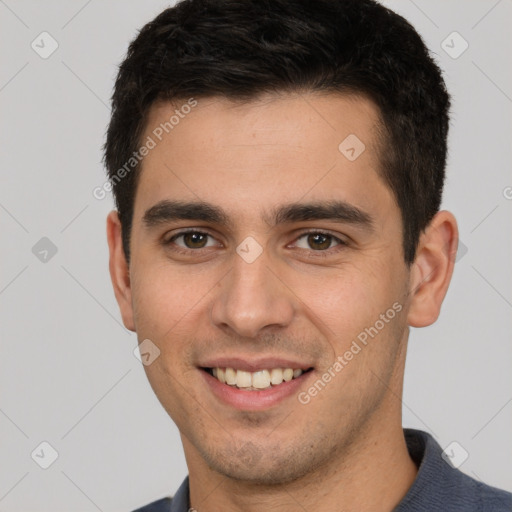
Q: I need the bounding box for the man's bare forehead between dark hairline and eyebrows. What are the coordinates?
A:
[131,94,389,228]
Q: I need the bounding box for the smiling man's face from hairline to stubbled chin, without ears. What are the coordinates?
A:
[111,94,409,483]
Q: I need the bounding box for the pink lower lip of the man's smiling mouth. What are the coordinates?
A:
[199,370,313,411]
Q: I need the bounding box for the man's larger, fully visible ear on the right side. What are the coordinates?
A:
[407,210,459,327]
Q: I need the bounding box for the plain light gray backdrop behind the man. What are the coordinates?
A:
[0,0,512,512]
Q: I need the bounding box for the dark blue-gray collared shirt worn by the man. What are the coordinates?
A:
[133,429,512,512]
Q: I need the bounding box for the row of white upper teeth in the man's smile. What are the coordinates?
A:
[212,368,303,389]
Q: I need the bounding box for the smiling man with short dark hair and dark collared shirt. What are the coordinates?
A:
[105,0,512,512]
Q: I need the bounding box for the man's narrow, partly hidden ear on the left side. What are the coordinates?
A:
[107,210,135,332]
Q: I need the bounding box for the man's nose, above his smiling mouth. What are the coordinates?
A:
[211,251,295,338]
